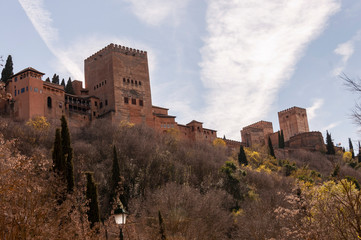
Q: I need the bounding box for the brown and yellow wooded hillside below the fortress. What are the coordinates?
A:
[0,117,361,240]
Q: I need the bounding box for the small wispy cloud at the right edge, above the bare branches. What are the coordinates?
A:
[332,31,361,76]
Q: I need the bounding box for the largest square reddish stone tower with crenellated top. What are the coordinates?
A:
[84,44,153,126]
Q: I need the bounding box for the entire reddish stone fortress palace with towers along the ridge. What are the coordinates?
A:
[0,44,324,150]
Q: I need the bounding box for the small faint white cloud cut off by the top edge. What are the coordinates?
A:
[124,0,189,26]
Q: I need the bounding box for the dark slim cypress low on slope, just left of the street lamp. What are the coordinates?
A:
[85,172,100,228]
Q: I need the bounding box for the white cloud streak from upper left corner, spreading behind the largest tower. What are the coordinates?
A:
[19,0,156,80]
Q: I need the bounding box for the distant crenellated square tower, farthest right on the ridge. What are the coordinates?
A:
[278,107,310,141]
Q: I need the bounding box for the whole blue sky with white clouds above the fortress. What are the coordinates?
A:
[0,0,361,149]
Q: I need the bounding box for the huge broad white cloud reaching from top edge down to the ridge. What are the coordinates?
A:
[200,0,340,138]
